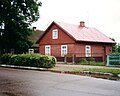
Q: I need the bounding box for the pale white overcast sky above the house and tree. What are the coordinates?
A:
[32,0,120,43]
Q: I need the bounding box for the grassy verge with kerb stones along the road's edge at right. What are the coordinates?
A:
[65,68,120,80]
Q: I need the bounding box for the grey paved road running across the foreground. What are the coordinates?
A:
[0,67,120,96]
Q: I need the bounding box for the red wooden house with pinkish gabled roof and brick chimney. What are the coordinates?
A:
[38,21,115,61]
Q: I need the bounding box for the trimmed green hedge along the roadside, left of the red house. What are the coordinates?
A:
[0,54,56,68]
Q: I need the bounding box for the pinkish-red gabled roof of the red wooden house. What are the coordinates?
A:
[37,21,115,43]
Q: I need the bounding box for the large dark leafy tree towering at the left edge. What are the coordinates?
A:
[0,0,41,52]
